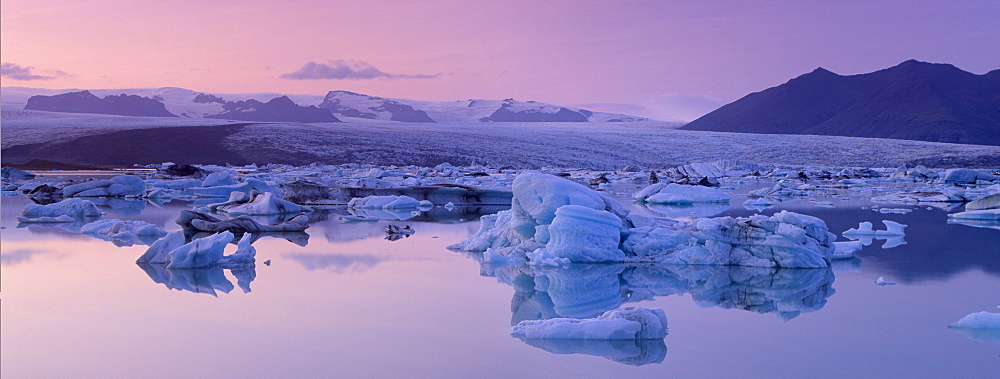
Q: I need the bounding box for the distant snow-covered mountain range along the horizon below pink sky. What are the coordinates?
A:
[0,87,646,123]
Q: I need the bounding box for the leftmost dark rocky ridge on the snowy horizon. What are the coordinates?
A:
[24,91,177,117]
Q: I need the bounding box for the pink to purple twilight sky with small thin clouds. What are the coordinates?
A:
[0,0,1000,121]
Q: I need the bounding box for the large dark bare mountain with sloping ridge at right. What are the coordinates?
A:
[681,60,1000,145]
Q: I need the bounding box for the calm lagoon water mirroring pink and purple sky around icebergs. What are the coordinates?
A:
[0,182,1000,378]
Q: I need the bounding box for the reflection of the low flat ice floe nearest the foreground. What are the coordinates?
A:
[521,338,667,366]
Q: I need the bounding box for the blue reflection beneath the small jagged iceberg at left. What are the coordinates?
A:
[136,263,257,297]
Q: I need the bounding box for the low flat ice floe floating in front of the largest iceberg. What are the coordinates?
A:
[511,307,667,340]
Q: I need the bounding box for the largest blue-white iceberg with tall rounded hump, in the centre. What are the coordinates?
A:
[451,172,835,268]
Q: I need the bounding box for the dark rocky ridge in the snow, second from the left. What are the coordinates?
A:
[205,94,340,122]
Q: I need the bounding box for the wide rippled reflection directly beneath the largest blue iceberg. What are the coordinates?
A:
[483,264,834,325]
